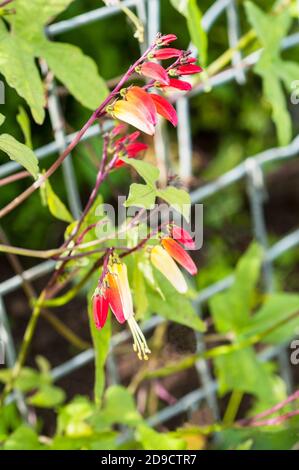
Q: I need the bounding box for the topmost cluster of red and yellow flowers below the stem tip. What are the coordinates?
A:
[107,34,202,135]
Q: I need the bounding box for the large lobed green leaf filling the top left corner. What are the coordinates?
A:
[0,0,108,115]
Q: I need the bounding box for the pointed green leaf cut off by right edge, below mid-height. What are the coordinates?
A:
[242,293,299,344]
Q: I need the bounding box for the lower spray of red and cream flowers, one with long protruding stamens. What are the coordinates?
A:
[93,225,197,360]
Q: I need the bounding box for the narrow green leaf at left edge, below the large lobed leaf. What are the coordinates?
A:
[0,134,38,179]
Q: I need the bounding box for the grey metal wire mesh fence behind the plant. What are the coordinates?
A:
[0,0,299,425]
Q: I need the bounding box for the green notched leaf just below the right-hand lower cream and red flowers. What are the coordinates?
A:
[147,270,206,332]
